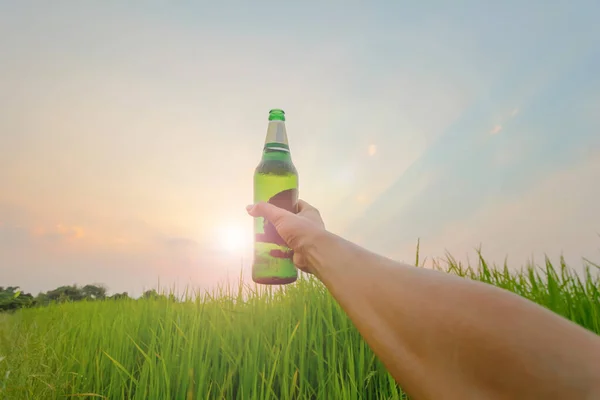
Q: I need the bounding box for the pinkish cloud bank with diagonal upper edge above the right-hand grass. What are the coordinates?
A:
[403,155,600,268]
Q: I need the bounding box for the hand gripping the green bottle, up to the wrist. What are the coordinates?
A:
[246,200,326,274]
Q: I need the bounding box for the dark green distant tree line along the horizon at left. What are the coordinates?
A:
[0,284,165,312]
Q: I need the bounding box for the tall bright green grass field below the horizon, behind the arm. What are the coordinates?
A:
[0,252,600,400]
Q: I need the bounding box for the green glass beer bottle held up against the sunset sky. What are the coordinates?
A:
[252,109,298,285]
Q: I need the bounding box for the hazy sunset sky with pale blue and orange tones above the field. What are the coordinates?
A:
[0,0,600,295]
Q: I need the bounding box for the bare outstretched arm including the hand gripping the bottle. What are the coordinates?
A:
[247,200,600,400]
